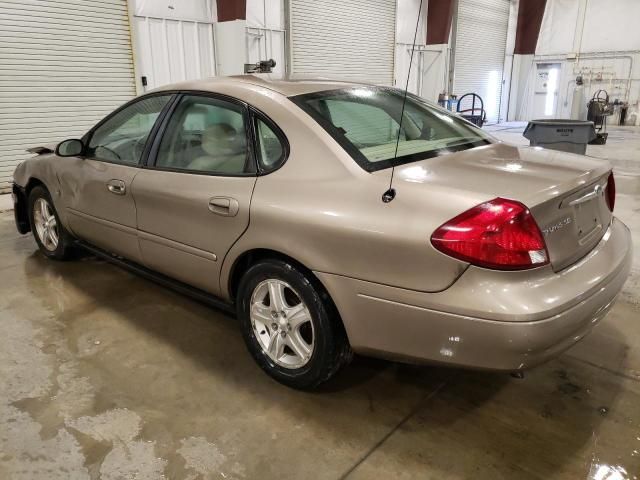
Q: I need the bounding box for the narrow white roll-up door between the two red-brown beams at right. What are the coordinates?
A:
[453,0,509,123]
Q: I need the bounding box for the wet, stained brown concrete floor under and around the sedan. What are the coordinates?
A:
[0,126,640,480]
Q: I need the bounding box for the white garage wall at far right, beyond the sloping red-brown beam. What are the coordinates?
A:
[509,0,640,120]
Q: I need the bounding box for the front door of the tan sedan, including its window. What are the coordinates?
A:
[59,94,172,262]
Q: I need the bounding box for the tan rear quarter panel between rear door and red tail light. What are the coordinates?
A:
[221,84,474,298]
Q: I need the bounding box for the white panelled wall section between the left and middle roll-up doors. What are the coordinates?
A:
[134,0,286,90]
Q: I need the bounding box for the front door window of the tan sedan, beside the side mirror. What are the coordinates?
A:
[85,95,171,165]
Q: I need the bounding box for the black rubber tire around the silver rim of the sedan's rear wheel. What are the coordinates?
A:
[236,260,353,390]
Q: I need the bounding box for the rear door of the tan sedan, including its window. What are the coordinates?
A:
[133,94,257,294]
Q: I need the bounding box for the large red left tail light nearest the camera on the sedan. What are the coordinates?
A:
[431,198,549,270]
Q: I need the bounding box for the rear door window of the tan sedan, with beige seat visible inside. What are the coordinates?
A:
[155,95,255,175]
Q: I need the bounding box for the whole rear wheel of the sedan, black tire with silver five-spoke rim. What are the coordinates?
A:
[236,260,352,390]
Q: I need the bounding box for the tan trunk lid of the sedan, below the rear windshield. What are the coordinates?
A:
[396,143,612,271]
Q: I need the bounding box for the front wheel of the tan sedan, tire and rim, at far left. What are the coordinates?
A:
[28,185,72,260]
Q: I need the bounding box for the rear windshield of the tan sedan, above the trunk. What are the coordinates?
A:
[291,87,493,171]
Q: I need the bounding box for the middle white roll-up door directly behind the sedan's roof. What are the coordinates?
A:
[289,0,396,85]
